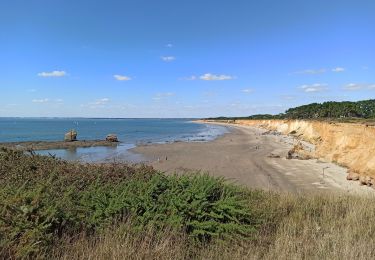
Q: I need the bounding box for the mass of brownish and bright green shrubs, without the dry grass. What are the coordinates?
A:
[0,150,260,257]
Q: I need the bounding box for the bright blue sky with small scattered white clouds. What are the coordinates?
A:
[0,0,375,118]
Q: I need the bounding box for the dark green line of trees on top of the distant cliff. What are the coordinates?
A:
[208,99,375,120]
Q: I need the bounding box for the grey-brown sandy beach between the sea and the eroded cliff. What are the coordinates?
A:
[131,122,374,194]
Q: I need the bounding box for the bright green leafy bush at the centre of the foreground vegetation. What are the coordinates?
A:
[113,174,256,241]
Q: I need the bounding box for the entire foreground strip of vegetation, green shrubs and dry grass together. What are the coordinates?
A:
[0,147,375,259]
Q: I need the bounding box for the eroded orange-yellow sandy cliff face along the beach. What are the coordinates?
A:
[235,120,375,181]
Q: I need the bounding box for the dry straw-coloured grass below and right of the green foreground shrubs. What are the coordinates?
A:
[56,194,375,259]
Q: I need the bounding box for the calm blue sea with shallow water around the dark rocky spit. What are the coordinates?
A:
[0,118,229,163]
